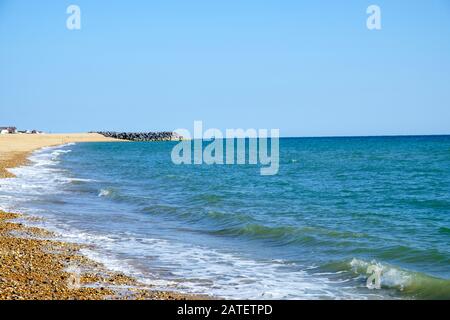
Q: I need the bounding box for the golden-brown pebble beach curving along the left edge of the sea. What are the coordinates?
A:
[0,133,200,300]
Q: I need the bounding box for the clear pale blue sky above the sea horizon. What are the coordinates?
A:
[0,0,450,136]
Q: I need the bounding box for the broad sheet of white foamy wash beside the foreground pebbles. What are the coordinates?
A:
[20,214,352,299]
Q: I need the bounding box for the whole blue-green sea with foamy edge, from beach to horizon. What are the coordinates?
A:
[0,136,450,299]
